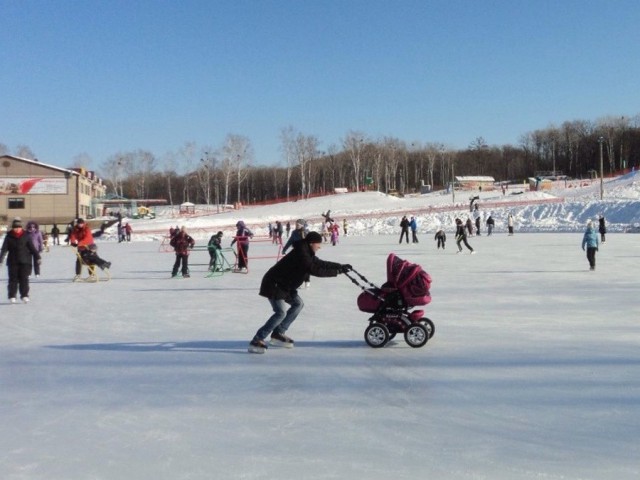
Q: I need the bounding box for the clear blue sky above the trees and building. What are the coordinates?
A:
[0,0,640,168]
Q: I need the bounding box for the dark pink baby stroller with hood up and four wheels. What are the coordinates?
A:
[346,253,435,348]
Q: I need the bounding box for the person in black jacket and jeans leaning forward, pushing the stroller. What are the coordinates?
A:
[248,232,352,353]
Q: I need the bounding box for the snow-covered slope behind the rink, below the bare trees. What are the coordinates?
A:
[104,172,640,240]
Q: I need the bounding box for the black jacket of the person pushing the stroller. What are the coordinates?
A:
[260,241,341,300]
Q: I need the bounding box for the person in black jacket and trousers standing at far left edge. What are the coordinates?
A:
[0,217,40,303]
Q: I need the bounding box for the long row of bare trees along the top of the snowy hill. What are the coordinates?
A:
[0,115,640,205]
